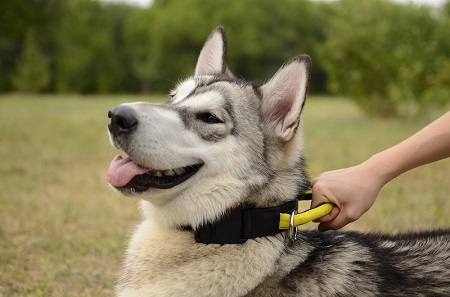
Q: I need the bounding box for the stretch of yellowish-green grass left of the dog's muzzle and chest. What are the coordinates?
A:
[0,96,157,296]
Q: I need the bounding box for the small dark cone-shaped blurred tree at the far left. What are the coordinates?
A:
[13,30,50,93]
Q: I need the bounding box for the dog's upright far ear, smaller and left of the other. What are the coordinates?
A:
[195,27,229,75]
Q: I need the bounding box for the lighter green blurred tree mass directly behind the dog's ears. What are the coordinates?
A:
[125,0,326,91]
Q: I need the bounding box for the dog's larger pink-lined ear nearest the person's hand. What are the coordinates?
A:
[261,55,311,141]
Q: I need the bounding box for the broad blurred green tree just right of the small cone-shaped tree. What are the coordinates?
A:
[56,0,138,93]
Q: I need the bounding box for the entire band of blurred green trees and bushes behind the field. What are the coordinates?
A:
[0,0,450,116]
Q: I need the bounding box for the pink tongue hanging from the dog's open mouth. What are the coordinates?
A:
[106,155,149,187]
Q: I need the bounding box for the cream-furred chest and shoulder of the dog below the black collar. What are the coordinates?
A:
[118,222,284,296]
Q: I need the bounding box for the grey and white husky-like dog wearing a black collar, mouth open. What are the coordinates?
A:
[107,27,450,297]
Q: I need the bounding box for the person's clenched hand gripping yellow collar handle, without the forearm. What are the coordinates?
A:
[311,163,384,231]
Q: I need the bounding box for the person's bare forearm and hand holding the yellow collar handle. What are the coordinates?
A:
[311,112,450,230]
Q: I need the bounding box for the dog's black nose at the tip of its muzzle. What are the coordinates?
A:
[108,105,138,136]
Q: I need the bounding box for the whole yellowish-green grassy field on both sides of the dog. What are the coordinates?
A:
[0,95,450,296]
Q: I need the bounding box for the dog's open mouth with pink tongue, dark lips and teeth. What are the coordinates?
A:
[107,155,203,192]
